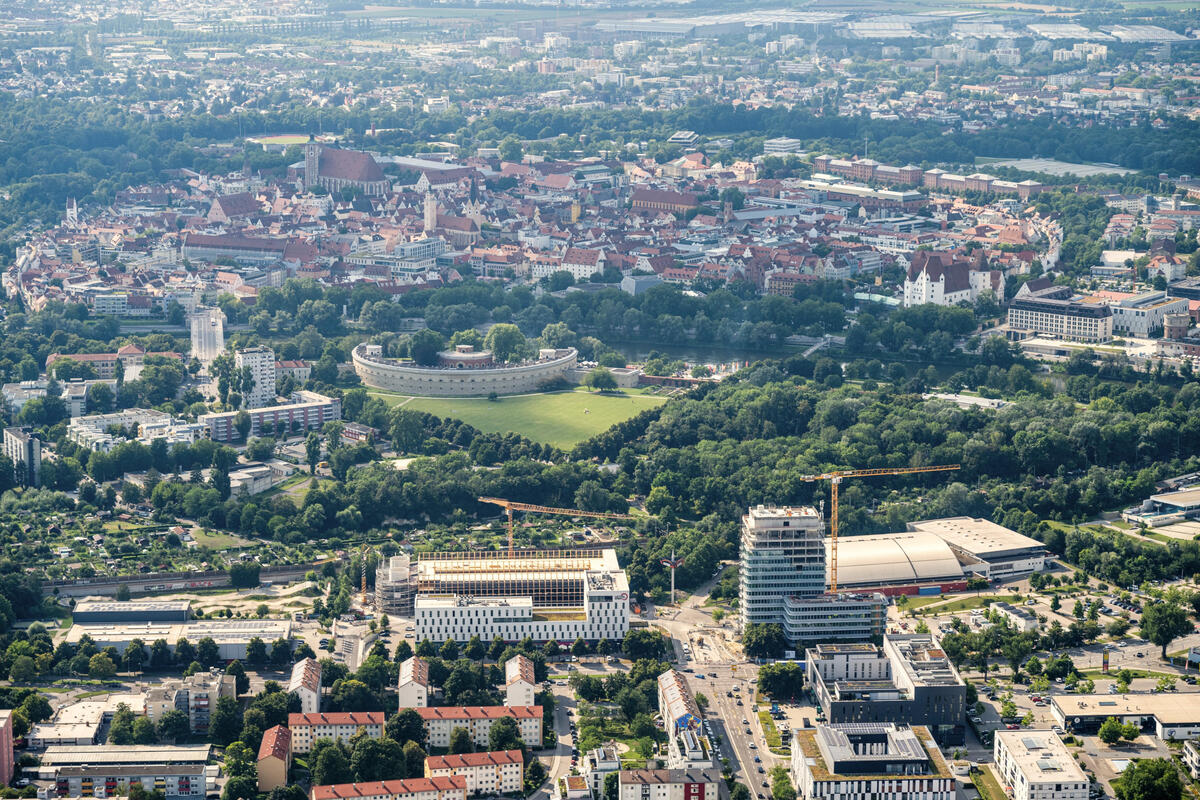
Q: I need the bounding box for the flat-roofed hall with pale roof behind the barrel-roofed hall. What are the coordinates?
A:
[908,517,1046,581]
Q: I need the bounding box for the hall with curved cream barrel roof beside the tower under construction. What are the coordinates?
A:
[826,531,967,596]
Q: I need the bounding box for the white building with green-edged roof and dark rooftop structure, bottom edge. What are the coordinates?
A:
[792,722,958,800]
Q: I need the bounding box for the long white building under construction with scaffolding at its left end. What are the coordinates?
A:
[405,549,629,642]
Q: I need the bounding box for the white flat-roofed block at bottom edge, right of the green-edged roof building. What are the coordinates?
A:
[992,730,1091,800]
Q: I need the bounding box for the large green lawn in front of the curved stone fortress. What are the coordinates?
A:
[371,390,666,449]
